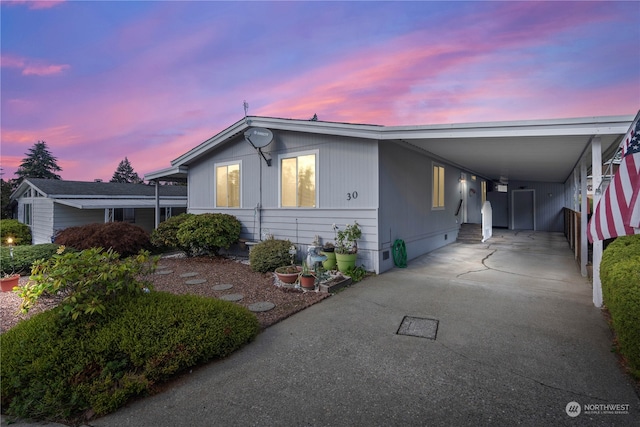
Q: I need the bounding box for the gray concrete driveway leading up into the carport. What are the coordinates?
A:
[3,230,640,427]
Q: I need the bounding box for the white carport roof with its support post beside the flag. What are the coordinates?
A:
[382,115,634,307]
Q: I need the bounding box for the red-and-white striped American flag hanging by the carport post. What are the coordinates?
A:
[587,111,640,242]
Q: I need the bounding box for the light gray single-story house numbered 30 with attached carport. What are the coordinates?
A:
[145,116,633,273]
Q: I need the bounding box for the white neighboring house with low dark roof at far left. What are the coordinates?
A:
[11,178,187,244]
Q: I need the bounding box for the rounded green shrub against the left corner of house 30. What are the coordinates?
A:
[177,213,242,255]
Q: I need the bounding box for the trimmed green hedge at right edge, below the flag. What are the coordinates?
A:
[600,235,640,378]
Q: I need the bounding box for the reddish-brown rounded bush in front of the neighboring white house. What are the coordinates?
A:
[55,222,151,256]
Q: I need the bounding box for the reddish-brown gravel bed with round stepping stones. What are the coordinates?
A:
[0,257,329,332]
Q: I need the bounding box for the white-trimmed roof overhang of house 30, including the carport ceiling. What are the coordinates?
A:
[145,115,635,186]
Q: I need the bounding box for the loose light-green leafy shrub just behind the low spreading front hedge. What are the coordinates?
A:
[18,248,157,320]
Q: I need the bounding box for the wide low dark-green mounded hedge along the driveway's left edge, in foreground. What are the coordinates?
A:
[0,292,259,423]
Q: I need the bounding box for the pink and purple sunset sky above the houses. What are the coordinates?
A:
[0,0,640,181]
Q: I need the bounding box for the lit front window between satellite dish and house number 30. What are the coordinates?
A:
[280,153,316,208]
